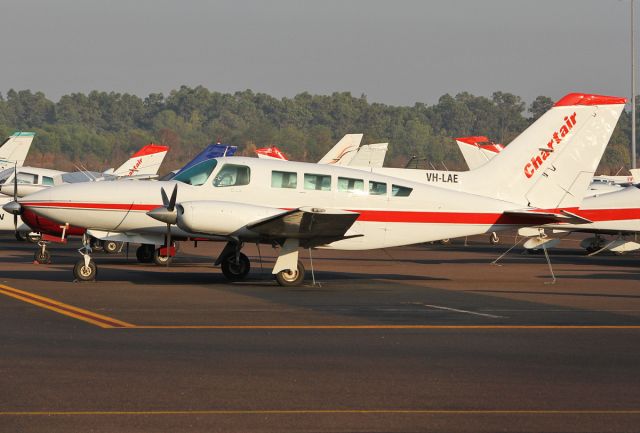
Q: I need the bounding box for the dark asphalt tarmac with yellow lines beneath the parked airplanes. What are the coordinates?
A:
[0,236,640,432]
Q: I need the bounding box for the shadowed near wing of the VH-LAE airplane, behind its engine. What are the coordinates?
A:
[247,207,360,248]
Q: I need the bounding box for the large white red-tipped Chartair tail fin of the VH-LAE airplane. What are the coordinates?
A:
[469,93,626,209]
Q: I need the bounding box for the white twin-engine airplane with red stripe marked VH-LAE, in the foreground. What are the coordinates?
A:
[4,94,625,285]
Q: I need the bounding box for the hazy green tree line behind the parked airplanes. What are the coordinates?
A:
[0,86,631,173]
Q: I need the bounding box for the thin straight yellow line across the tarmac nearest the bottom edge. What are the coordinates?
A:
[0,409,640,416]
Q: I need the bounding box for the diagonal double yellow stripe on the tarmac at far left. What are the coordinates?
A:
[0,284,135,328]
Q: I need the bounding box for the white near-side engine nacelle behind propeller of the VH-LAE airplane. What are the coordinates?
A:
[176,200,283,236]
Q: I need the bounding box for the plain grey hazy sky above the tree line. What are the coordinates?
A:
[0,0,640,105]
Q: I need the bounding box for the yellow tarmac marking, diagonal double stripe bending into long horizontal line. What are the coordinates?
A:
[0,284,640,331]
